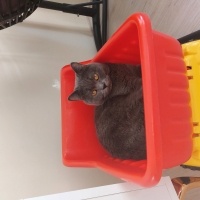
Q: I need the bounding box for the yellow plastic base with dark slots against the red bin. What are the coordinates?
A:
[182,40,200,169]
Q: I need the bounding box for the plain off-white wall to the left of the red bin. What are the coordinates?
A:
[0,1,120,200]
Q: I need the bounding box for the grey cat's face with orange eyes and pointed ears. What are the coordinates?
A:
[68,63,112,106]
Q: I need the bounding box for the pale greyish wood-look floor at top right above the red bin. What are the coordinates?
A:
[108,0,200,38]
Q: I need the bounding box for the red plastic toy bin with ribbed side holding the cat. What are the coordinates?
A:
[61,13,192,186]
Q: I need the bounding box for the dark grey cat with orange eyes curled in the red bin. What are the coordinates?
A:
[68,62,146,160]
